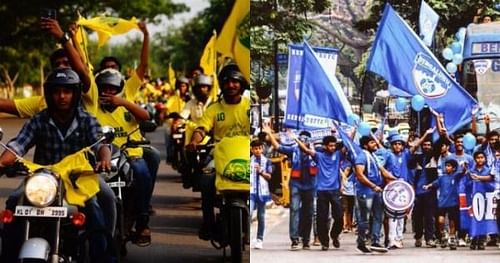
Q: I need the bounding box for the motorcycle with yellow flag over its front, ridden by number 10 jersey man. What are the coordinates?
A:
[195,136,250,263]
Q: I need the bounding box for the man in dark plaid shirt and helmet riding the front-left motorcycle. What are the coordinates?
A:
[0,68,111,262]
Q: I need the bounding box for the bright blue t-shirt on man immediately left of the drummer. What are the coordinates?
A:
[314,150,342,191]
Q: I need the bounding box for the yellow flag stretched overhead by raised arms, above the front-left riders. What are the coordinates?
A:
[77,16,139,46]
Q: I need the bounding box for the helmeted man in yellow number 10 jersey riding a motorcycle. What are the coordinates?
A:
[187,64,250,240]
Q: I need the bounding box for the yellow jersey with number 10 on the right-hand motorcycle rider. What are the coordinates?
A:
[198,97,250,142]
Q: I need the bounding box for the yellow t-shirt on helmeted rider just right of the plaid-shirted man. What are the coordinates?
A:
[95,106,142,157]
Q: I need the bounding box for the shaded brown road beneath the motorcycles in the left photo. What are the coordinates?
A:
[0,118,249,263]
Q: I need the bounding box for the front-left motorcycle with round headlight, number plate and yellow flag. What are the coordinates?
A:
[0,127,114,263]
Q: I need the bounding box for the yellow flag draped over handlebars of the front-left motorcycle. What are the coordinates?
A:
[22,147,99,206]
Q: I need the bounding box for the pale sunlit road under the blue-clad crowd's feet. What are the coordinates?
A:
[250,207,500,263]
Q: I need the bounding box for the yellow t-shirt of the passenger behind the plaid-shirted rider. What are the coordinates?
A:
[14,75,98,118]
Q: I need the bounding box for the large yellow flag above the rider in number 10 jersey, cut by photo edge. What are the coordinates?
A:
[216,0,250,81]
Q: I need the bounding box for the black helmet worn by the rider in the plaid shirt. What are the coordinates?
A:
[43,68,82,109]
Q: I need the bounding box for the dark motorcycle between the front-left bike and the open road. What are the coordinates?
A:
[101,121,157,257]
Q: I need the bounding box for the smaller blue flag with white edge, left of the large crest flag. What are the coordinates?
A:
[299,42,352,129]
